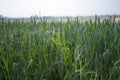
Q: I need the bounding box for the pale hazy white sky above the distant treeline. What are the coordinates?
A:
[0,0,120,17]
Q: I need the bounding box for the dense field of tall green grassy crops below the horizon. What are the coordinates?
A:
[0,17,120,80]
